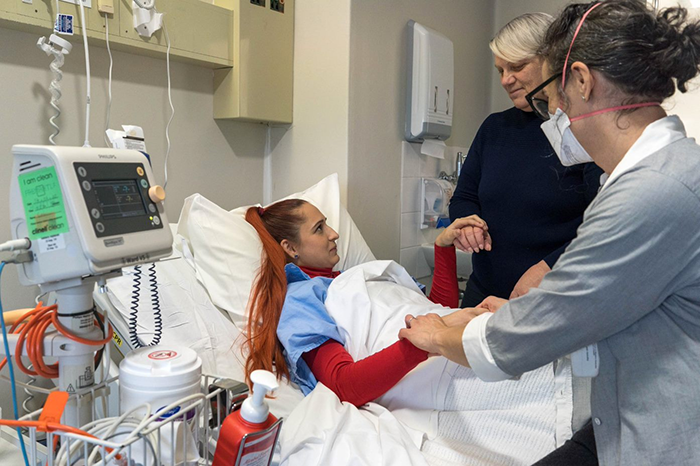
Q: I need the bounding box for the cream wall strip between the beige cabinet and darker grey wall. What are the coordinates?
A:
[266,0,350,203]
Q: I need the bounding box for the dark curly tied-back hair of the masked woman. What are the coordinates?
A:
[539,0,700,102]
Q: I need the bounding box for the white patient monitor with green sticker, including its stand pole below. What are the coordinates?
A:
[9,145,172,425]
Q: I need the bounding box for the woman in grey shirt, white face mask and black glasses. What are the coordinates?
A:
[401,0,700,466]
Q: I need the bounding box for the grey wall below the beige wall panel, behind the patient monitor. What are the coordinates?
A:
[0,28,265,417]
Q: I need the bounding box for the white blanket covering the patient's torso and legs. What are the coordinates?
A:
[281,261,556,466]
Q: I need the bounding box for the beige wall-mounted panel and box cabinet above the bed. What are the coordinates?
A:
[0,0,294,124]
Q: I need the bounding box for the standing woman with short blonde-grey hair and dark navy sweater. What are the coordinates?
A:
[450,13,602,307]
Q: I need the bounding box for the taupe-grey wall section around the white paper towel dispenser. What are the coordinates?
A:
[348,0,494,261]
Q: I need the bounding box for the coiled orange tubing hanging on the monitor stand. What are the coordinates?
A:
[0,303,112,379]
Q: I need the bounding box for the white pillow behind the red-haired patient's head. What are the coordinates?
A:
[178,174,374,330]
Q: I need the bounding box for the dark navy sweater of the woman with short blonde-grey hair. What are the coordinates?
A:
[450,107,603,298]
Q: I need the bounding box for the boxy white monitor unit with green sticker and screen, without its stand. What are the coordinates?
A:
[10,145,172,284]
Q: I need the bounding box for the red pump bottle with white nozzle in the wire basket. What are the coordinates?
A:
[212,370,282,466]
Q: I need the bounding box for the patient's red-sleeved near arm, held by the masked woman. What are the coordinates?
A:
[302,340,428,406]
